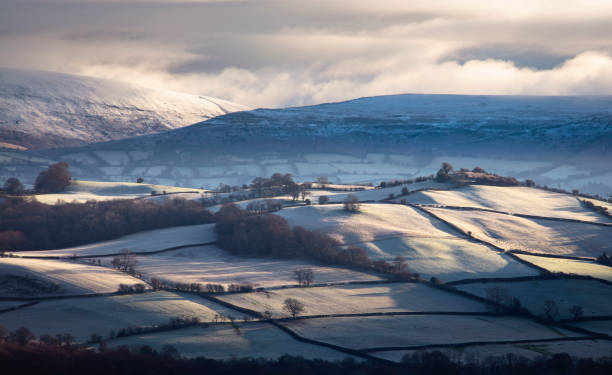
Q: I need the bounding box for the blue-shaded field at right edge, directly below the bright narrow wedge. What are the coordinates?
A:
[455,279,612,319]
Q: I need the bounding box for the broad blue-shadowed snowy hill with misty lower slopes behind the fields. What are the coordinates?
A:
[0,95,612,196]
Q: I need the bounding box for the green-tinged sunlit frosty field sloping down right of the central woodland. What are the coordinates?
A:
[359,237,539,281]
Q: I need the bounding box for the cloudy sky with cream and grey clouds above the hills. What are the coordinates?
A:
[0,0,612,107]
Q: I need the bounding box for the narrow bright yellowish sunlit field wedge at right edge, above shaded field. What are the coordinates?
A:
[516,254,612,281]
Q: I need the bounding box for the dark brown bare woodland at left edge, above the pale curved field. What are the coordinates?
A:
[0,198,214,251]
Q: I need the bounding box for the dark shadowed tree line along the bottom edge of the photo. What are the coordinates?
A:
[0,341,612,375]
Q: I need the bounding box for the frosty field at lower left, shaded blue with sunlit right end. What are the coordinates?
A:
[0,292,234,342]
